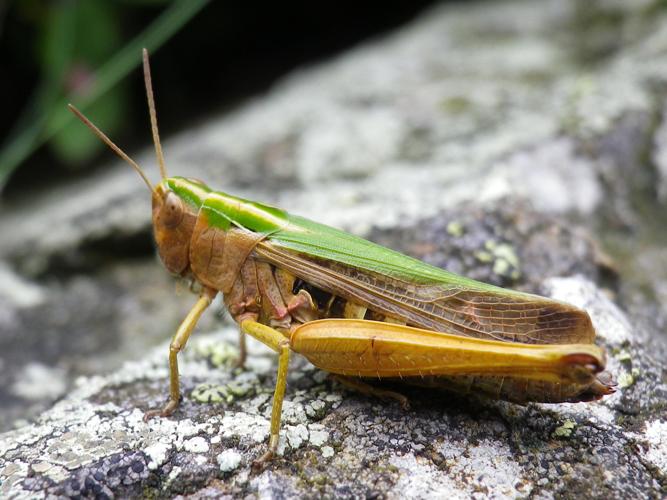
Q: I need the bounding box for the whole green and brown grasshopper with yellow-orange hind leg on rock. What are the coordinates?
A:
[70,49,615,464]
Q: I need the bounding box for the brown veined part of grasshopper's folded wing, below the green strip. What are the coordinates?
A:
[255,241,595,344]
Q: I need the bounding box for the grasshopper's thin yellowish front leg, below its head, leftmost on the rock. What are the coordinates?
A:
[144,288,218,422]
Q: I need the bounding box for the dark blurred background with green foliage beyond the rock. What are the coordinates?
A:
[0,0,433,198]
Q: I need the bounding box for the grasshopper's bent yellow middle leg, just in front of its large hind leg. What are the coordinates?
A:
[241,320,290,466]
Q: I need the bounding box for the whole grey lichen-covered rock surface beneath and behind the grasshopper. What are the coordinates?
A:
[0,0,667,498]
